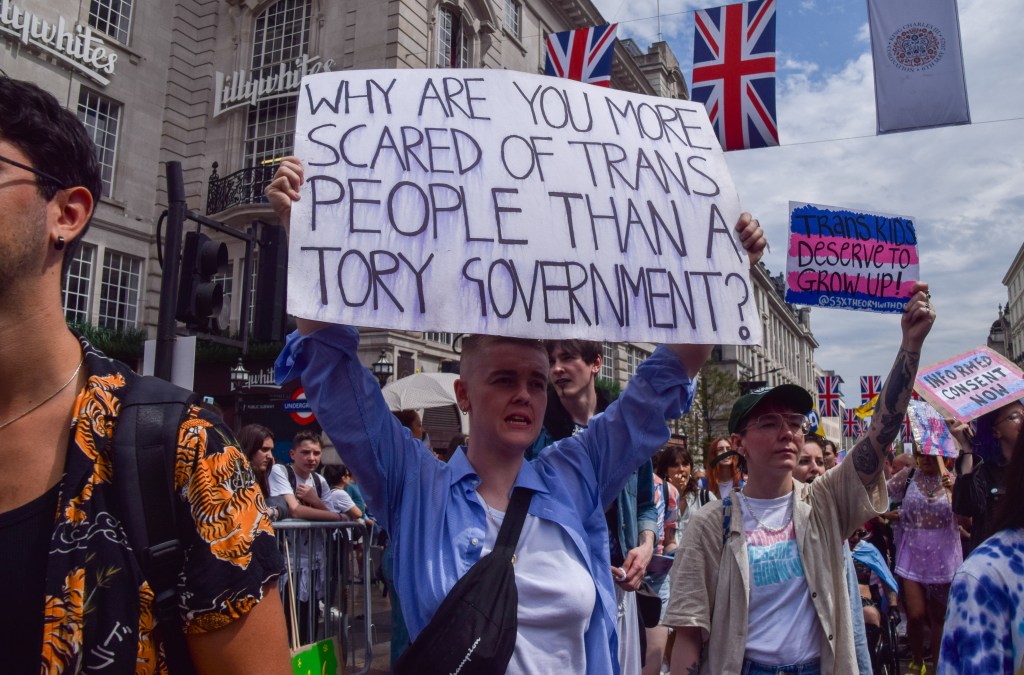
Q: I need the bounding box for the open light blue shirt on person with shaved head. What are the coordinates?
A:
[275,326,694,673]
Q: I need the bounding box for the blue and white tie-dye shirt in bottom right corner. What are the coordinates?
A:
[938,529,1024,675]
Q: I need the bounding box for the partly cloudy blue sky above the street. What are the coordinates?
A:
[594,0,1024,406]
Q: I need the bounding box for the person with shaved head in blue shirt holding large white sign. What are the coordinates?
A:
[266,158,765,673]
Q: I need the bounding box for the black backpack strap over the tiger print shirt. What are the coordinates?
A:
[112,377,198,675]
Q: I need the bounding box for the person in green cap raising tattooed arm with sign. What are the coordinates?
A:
[666,283,935,675]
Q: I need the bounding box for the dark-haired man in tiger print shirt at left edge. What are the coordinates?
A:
[0,75,290,673]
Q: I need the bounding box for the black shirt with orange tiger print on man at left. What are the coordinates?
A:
[41,338,284,675]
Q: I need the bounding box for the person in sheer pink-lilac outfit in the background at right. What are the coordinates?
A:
[887,444,964,675]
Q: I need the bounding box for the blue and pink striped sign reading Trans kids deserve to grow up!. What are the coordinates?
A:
[785,202,919,313]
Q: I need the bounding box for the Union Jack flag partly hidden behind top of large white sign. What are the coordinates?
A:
[544,24,618,87]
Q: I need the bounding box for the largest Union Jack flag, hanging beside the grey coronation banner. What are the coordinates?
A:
[692,0,778,151]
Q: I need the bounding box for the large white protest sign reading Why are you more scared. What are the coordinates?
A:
[288,70,761,344]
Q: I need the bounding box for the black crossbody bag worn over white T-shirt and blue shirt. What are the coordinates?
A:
[394,488,534,675]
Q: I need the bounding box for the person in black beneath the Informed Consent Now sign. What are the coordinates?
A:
[949,400,1024,557]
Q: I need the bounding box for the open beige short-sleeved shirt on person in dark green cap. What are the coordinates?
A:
[664,460,889,675]
